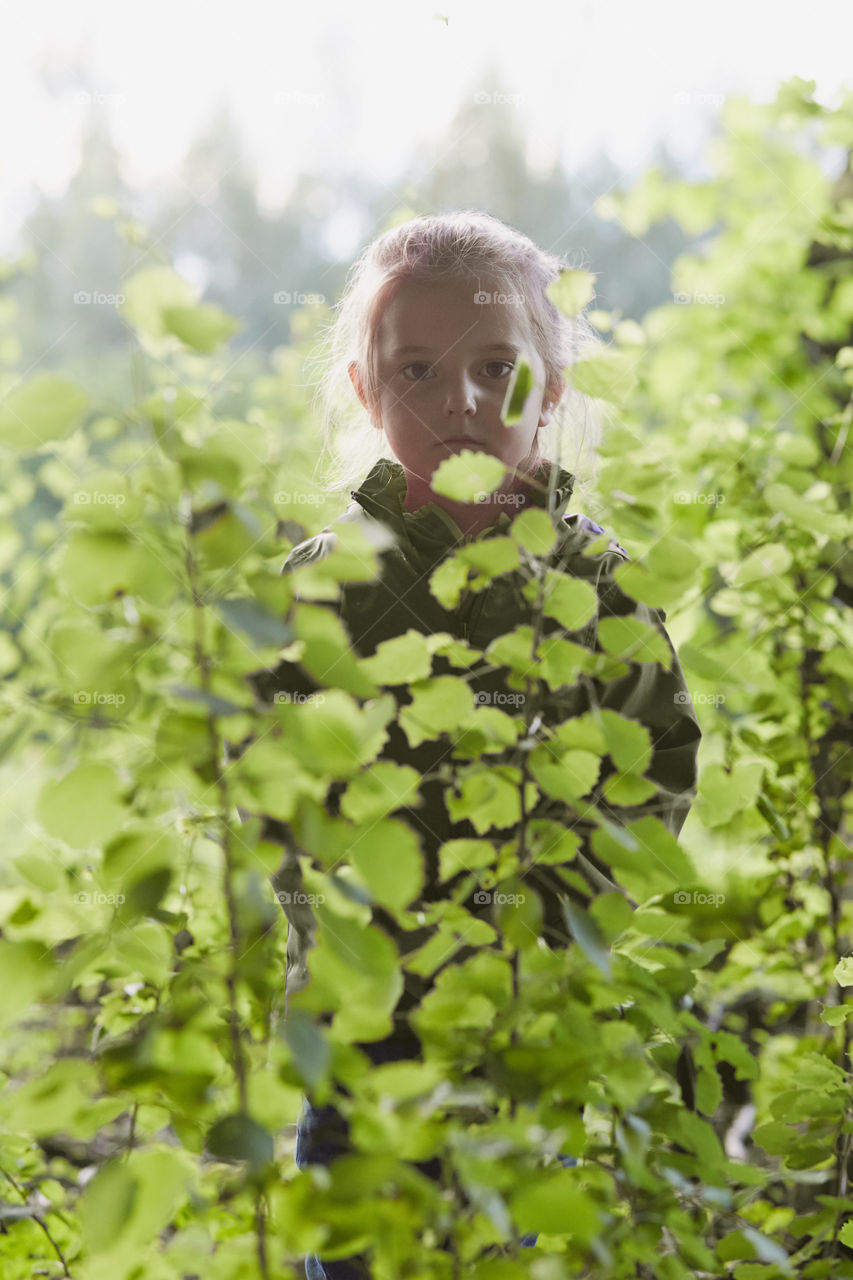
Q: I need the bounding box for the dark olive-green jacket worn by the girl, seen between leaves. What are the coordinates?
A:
[244,458,701,1021]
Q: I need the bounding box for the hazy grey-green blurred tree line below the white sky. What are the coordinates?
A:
[0,70,689,410]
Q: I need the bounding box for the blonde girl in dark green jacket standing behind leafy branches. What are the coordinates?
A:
[244,212,701,1280]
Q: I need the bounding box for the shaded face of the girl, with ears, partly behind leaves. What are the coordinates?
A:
[350,275,562,489]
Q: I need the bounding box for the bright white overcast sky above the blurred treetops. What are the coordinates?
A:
[0,0,853,248]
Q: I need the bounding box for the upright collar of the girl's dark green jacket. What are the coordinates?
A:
[351,458,575,553]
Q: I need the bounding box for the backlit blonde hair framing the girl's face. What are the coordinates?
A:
[302,210,606,504]
